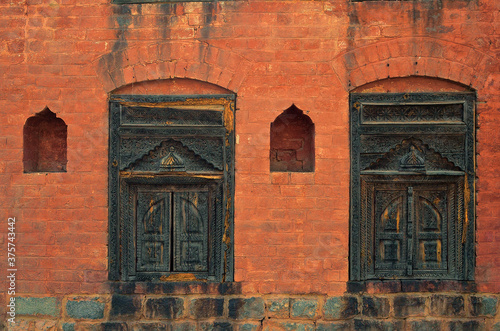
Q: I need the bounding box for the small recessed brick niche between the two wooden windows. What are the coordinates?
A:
[269,104,314,172]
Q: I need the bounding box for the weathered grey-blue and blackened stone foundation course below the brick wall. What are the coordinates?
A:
[7,289,500,331]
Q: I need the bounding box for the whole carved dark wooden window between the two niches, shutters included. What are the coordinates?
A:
[110,95,234,281]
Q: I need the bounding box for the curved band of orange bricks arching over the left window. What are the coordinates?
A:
[96,41,249,92]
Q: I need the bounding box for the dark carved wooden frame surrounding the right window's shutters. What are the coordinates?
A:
[348,92,476,289]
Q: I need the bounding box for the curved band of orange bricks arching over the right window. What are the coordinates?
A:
[332,38,499,91]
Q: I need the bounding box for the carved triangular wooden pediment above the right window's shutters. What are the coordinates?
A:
[364,138,463,173]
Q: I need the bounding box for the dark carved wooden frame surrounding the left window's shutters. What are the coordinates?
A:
[109,95,235,282]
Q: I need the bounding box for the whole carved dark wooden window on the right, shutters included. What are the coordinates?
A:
[350,93,475,281]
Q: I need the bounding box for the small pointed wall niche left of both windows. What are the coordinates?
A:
[23,107,68,172]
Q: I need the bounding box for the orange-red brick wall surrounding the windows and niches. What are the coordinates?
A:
[0,0,500,314]
